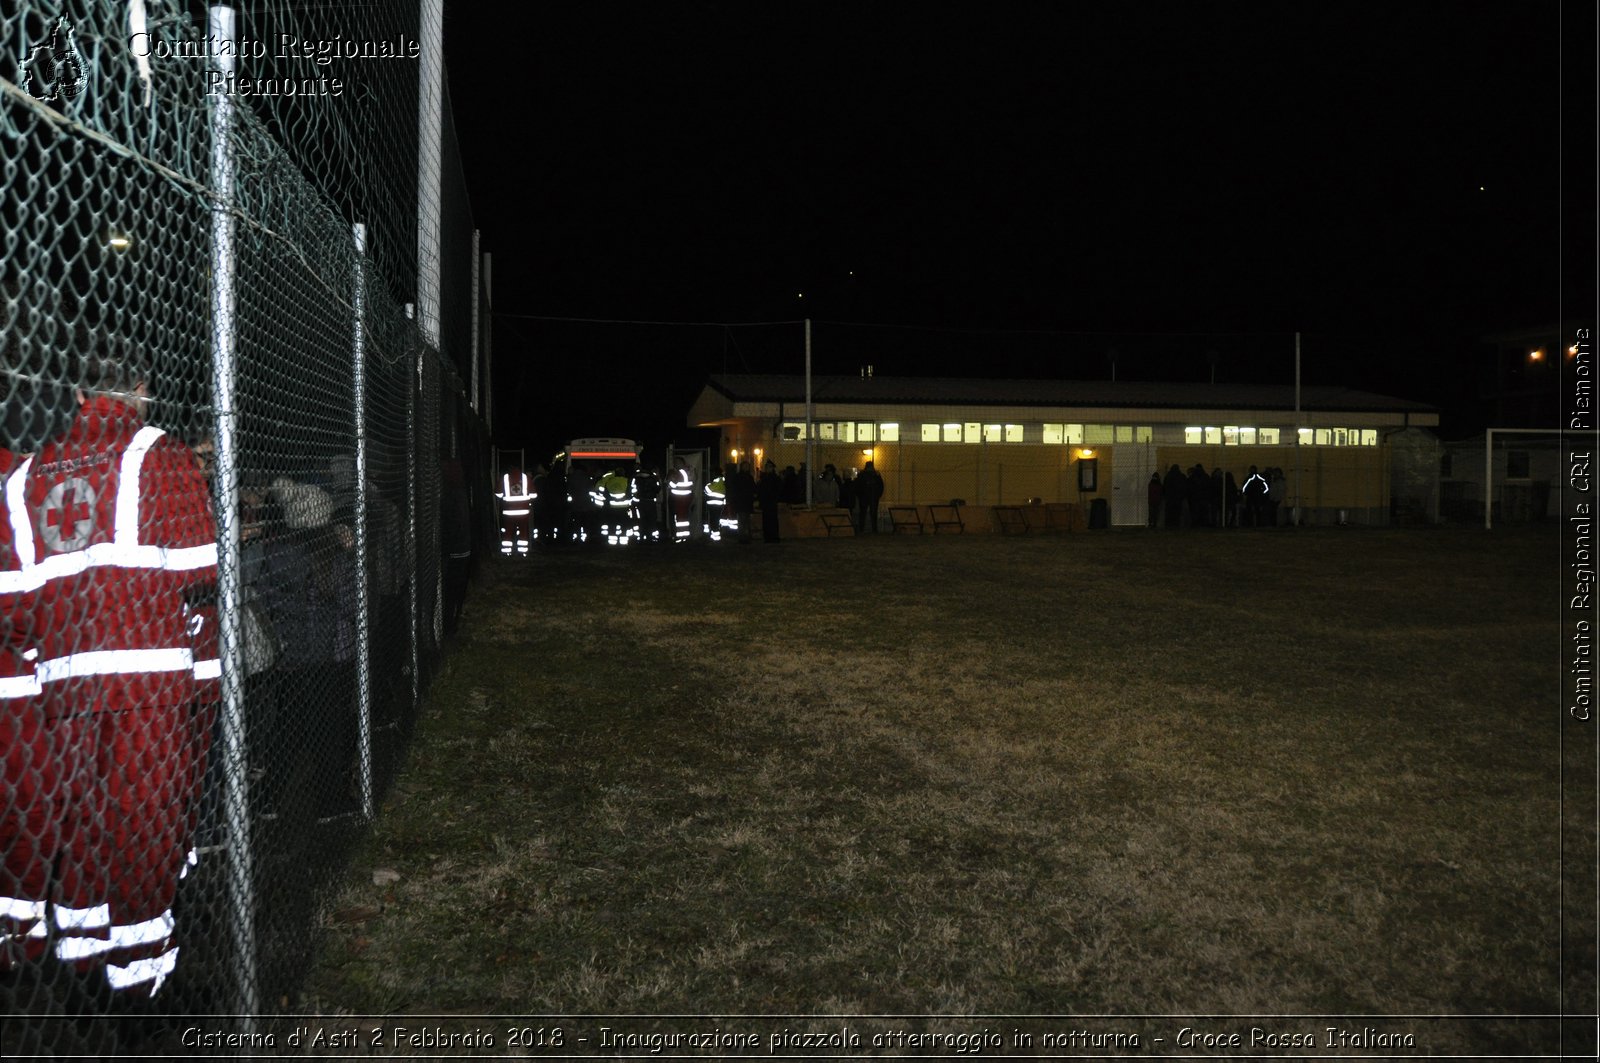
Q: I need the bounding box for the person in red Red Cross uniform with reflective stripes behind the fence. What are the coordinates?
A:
[0,344,221,996]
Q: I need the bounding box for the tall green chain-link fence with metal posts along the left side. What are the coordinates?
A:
[0,0,493,1055]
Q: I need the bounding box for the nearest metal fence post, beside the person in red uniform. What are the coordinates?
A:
[206,6,258,1033]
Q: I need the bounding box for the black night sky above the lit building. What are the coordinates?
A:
[445,0,1595,451]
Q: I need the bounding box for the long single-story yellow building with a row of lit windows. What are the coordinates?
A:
[688,375,1438,525]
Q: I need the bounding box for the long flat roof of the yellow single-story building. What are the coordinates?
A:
[707,373,1437,413]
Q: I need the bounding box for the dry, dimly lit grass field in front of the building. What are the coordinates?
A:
[302,528,1594,1055]
